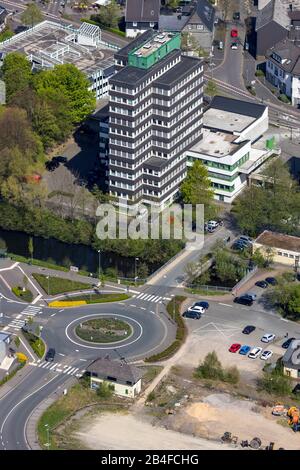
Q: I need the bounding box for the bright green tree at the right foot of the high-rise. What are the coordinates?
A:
[180,160,217,220]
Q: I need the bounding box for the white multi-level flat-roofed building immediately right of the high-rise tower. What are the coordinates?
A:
[186,96,272,203]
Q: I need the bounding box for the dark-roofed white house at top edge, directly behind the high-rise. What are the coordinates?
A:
[125,0,160,38]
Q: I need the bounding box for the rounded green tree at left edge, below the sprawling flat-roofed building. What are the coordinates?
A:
[1,52,32,103]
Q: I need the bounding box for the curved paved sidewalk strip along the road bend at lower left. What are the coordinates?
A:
[24,377,76,450]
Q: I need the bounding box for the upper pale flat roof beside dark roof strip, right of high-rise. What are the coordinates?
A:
[203,108,256,133]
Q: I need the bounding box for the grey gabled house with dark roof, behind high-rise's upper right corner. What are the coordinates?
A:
[183,0,216,50]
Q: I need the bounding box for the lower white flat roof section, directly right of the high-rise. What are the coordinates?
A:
[190,128,247,158]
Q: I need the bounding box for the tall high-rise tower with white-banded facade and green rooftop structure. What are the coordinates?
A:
[109,30,203,210]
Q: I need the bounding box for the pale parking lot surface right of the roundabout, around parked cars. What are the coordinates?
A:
[182,299,300,382]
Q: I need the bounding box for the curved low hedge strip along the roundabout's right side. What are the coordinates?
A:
[145,295,187,362]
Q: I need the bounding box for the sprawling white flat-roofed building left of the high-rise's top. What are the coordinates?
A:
[0,21,117,99]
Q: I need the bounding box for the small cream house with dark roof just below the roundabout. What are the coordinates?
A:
[87,357,143,398]
